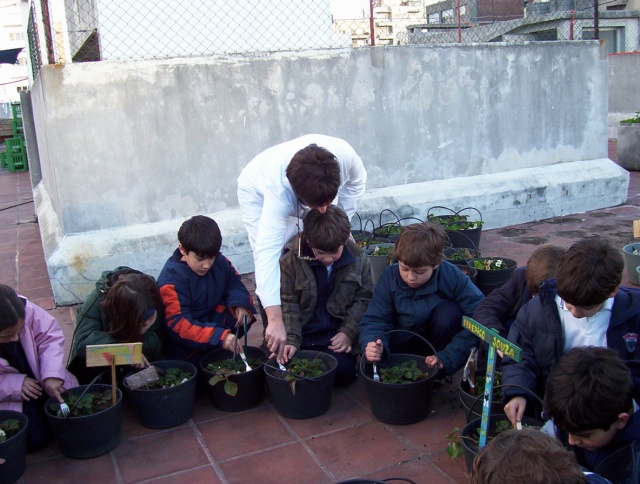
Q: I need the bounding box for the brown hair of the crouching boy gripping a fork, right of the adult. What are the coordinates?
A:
[395,222,447,267]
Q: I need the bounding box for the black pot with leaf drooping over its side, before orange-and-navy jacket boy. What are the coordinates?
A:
[200,346,266,412]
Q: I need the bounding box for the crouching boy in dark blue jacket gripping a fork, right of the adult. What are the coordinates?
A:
[360,222,483,375]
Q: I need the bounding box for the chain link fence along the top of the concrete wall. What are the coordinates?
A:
[28,0,640,76]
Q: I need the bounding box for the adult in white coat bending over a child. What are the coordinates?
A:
[238,134,367,359]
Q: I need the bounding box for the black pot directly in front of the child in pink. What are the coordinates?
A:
[45,384,122,459]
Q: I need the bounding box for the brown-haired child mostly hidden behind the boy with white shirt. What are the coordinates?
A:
[473,245,567,337]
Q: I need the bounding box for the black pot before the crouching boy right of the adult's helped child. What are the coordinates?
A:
[360,354,437,425]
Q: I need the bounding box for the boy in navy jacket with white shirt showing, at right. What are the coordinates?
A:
[502,237,640,427]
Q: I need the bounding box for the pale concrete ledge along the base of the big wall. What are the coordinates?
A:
[34,158,629,305]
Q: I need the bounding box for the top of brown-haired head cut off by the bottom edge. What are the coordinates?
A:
[469,429,587,484]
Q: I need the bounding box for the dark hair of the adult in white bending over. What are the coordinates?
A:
[286,144,340,208]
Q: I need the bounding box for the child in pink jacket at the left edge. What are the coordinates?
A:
[0,284,78,452]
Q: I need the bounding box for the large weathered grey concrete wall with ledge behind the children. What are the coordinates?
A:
[27,41,628,304]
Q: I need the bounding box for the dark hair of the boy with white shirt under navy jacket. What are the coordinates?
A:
[556,236,624,307]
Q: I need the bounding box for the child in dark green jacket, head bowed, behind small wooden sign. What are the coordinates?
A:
[68,267,164,383]
